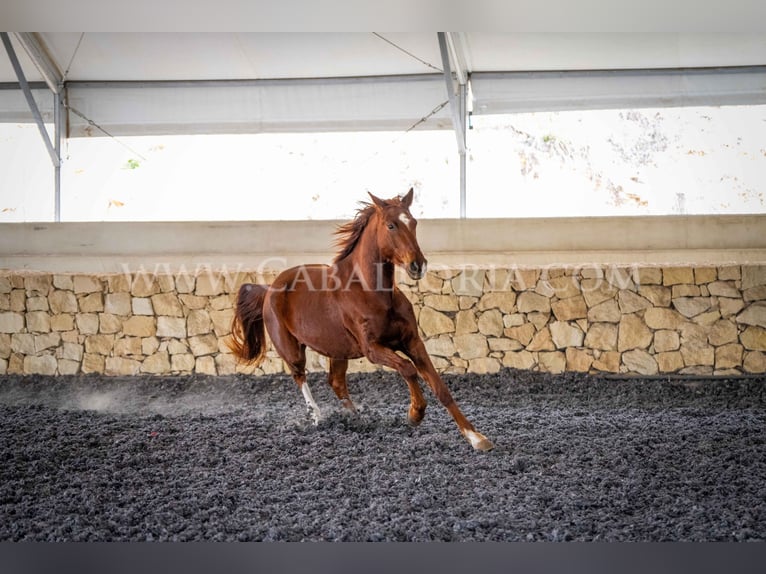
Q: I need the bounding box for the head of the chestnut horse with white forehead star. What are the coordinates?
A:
[370,188,427,279]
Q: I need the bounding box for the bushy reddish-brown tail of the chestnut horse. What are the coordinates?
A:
[226,283,267,365]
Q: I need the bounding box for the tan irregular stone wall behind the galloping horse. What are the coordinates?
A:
[0,265,766,375]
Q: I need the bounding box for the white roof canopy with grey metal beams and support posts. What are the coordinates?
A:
[0,32,766,217]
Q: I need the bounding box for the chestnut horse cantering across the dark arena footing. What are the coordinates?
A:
[229,189,493,450]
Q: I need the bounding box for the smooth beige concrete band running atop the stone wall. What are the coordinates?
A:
[0,215,766,273]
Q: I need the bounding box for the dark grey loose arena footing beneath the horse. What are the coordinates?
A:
[0,371,766,541]
